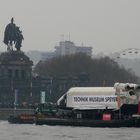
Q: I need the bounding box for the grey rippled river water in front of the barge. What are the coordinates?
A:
[0,121,140,140]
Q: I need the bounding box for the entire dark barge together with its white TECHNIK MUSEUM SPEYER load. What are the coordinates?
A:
[8,83,140,127]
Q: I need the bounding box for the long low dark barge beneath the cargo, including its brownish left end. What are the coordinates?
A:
[8,112,140,128]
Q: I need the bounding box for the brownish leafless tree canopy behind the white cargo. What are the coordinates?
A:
[34,54,138,86]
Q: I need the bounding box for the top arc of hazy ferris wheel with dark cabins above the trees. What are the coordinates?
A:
[116,48,140,59]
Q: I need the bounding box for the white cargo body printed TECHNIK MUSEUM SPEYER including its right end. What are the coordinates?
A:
[57,83,139,110]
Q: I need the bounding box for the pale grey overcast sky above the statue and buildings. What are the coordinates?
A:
[0,0,140,53]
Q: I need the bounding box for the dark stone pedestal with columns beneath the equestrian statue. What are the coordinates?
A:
[0,51,33,106]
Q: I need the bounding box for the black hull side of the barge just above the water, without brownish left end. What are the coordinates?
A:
[35,119,140,128]
